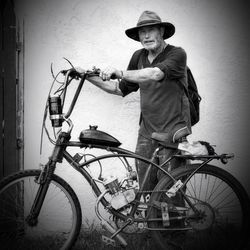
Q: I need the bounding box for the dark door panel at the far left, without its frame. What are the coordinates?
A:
[0,0,19,179]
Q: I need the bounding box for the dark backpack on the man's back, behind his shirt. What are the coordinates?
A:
[185,67,201,126]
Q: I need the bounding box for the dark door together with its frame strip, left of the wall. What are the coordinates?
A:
[0,0,24,179]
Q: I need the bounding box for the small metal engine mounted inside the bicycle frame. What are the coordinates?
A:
[104,171,138,209]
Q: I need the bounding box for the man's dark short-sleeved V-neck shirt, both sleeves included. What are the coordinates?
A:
[119,45,191,141]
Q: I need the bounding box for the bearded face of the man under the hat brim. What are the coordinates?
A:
[139,26,164,50]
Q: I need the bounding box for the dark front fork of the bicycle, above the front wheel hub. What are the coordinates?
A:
[26,132,70,226]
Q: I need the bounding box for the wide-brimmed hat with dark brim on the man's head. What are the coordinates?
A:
[125,10,175,41]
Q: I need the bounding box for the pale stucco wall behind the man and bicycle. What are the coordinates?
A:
[15,0,250,219]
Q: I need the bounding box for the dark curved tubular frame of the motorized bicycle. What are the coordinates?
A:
[33,125,234,227]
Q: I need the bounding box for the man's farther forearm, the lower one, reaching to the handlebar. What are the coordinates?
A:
[87,76,122,96]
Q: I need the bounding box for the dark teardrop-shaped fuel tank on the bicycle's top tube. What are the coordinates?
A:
[79,125,121,147]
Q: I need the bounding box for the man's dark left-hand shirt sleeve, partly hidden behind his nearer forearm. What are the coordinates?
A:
[119,50,142,96]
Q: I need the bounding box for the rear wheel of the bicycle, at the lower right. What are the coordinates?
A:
[149,164,250,250]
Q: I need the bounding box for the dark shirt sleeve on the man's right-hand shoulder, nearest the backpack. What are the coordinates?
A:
[155,47,187,79]
